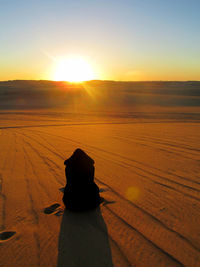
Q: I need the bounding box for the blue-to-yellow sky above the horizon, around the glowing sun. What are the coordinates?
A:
[0,0,200,81]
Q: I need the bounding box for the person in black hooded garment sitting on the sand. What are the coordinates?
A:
[63,148,100,211]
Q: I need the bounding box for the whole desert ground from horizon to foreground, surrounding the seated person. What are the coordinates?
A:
[0,81,200,267]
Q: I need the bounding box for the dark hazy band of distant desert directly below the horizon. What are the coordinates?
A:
[0,80,200,109]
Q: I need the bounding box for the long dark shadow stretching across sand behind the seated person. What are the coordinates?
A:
[58,208,113,267]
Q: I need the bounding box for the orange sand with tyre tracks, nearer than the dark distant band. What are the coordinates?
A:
[0,114,200,267]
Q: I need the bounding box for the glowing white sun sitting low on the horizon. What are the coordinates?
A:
[54,56,95,82]
